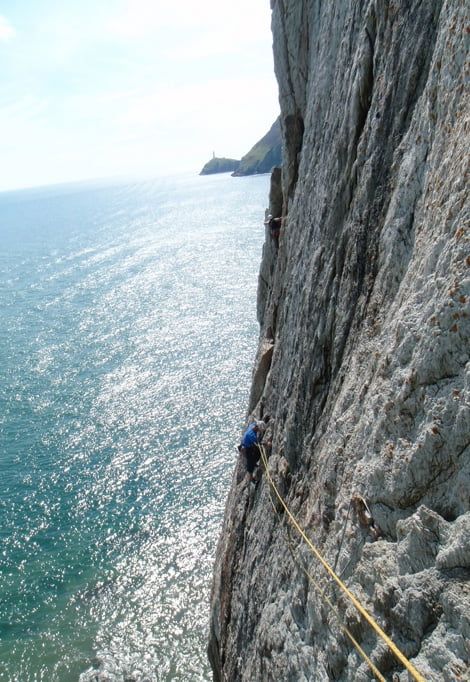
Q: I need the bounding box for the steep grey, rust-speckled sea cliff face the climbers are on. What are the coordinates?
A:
[209,0,470,682]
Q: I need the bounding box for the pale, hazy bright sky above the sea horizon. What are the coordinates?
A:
[0,0,279,191]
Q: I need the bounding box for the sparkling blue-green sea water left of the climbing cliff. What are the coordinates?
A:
[0,175,269,682]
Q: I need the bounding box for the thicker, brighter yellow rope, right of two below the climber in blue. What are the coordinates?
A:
[259,445,426,682]
